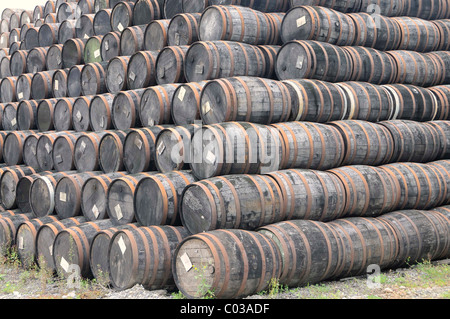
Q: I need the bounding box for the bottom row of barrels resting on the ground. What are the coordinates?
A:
[0,196,450,298]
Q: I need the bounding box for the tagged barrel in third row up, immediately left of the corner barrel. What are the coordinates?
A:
[154,124,201,173]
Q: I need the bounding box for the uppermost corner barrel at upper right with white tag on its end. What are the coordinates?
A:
[280,5,357,45]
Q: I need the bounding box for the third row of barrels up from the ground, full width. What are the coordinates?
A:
[0,120,450,179]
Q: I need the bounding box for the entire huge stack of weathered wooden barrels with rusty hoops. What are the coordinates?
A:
[0,0,450,298]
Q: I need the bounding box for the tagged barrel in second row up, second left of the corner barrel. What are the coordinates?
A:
[106,172,156,225]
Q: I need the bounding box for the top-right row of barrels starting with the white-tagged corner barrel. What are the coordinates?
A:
[284,6,450,52]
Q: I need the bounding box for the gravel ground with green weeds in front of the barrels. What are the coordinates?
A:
[0,260,450,299]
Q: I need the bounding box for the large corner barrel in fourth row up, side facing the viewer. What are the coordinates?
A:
[200,77,295,124]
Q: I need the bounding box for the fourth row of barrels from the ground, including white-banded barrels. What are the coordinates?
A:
[0,77,450,132]
